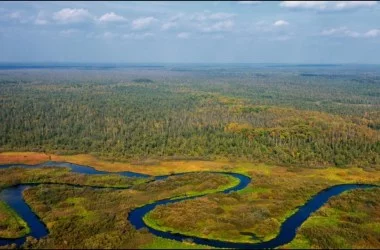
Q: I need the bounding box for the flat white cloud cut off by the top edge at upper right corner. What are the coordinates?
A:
[280,1,377,11]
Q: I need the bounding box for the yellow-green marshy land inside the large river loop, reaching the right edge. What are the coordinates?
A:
[144,167,380,245]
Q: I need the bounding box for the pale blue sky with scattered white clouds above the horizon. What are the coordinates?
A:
[0,1,380,64]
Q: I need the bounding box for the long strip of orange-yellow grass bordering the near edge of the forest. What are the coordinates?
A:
[0,152,380,183]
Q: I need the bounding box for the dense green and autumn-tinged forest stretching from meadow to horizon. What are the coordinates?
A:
[0,65,380,169]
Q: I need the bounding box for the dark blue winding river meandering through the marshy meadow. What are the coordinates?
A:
[0,161,378,249]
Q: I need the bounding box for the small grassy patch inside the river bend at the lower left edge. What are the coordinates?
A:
[0,201,30,238]
